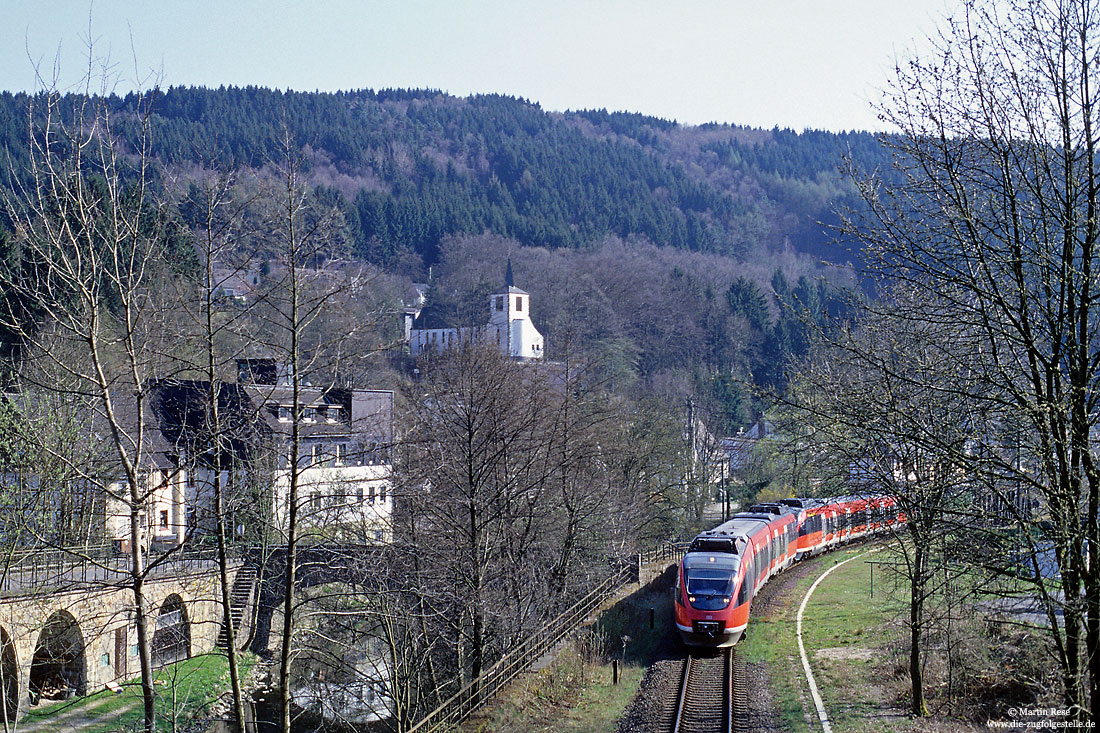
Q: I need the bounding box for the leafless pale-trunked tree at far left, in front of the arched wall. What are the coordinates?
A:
[0,78,180,731]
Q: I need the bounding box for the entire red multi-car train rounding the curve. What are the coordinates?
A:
[674,496,904,647]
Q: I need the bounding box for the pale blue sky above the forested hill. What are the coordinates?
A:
[0,0,950,130]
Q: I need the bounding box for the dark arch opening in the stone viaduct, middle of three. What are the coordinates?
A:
[29,611,88,701]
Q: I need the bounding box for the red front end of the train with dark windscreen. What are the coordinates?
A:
[674,551,749,647]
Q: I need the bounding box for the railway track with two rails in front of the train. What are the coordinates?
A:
[672,649,743,733]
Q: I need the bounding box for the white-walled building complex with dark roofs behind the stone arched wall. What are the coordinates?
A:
[91,359,394,548]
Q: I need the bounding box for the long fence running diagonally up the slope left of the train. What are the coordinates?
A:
[408,543,685,733]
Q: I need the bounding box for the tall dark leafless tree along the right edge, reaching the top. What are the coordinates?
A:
[848,0,1100,719]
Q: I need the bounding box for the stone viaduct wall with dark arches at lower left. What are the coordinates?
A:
[0,555,244,722]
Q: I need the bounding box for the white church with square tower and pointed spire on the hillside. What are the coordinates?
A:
[405,260,543,361]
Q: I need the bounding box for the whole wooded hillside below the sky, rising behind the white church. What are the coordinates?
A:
[0,87,875,435]
